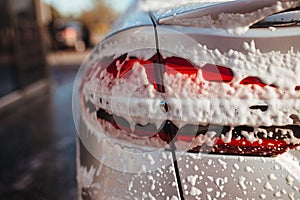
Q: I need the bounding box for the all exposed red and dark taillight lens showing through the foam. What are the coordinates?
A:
[89,54,300,156]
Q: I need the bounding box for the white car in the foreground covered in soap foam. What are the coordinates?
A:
[73,0,300,200]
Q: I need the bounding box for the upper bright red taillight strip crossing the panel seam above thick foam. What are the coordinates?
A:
[107,54,234,84]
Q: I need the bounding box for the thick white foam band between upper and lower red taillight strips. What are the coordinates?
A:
[83,45,300,127]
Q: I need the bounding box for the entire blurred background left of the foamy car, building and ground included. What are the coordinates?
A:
[0,0,133,200]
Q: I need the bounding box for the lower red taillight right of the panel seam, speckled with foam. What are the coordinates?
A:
[176,125,300,156]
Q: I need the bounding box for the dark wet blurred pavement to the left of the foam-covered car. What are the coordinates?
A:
[0,52,87,200]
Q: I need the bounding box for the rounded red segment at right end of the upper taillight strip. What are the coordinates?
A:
[201,64,234,83]
